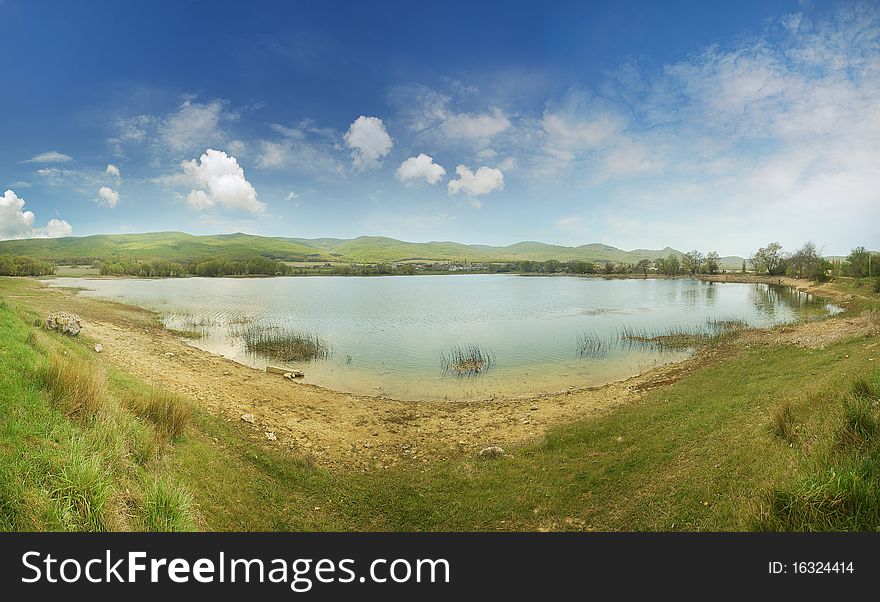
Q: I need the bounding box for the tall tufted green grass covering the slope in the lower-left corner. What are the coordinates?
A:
[0,290,197,531]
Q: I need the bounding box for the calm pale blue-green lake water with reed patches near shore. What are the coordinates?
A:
[50,275,833,399]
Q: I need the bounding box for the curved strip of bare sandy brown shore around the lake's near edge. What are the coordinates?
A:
[22,278,877,470]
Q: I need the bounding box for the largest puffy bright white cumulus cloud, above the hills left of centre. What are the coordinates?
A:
[181,148,266,213]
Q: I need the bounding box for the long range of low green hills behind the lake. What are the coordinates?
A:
[0,232,743,269]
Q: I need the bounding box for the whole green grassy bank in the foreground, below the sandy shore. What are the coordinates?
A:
[0,279,880,530]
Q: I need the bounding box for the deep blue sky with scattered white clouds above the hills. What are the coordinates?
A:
[0,0,880,255]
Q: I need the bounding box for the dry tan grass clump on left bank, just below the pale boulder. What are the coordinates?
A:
[41,353,107,418]
